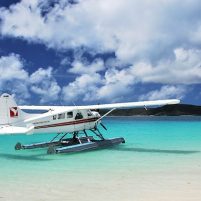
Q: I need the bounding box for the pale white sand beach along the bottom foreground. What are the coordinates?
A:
[0,162,201,201]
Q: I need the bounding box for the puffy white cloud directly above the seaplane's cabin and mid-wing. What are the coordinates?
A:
[63,66,137,102]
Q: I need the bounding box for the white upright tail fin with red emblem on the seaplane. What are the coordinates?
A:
[0,93,23,125]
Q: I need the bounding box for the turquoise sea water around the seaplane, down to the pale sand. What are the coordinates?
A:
[0,117,201,182]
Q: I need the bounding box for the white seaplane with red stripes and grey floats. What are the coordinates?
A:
[0,93,180,154]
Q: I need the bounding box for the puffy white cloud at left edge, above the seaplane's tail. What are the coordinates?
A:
[0,54,61,104]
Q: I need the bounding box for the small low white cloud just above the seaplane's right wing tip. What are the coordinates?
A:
[139,85,187,100]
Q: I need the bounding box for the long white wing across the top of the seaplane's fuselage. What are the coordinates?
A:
[23,99,180,123]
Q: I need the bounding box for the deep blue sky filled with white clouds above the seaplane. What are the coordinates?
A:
[0,0,201,105]
